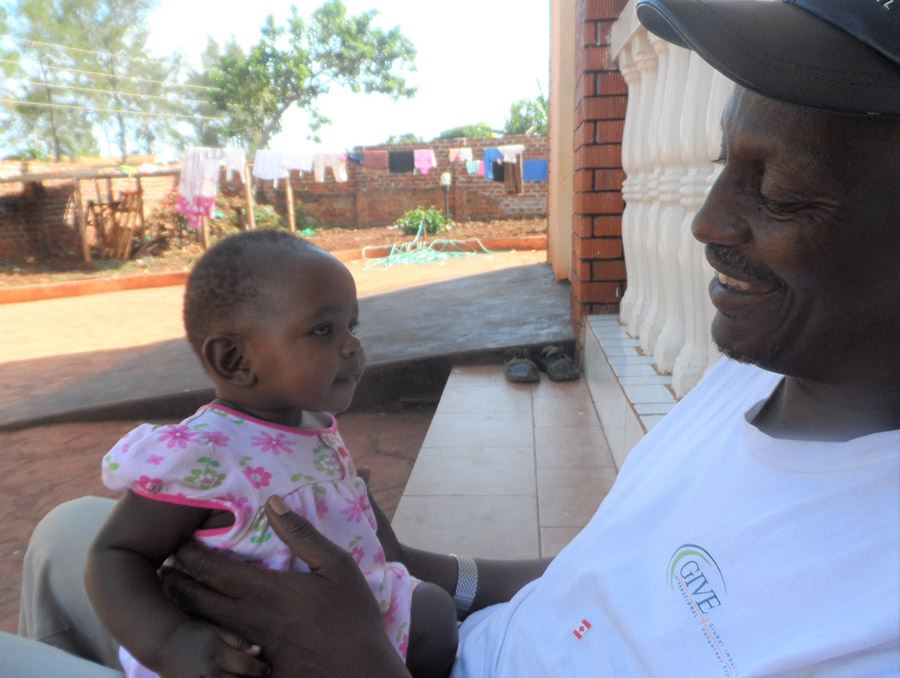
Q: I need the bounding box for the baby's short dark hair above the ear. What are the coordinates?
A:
[183,230,321,358]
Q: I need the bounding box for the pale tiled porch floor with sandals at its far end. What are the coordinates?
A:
[393,366,616,558]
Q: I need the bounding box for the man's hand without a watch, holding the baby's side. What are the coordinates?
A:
[163,495,409,678]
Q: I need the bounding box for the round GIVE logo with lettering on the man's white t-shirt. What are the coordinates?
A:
[668,544,737,676]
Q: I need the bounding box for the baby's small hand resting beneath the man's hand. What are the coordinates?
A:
[155,620,269,678]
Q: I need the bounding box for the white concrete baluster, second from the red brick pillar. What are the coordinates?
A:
[623,28,657,337]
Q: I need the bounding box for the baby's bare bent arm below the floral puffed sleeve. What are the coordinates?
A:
[85,492,266,675]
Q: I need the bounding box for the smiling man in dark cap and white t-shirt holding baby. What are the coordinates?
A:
[7,0,900,678]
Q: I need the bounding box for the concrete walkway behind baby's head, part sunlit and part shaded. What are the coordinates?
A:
[0,252,574,430]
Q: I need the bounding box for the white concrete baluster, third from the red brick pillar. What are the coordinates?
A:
[638,34,671,355]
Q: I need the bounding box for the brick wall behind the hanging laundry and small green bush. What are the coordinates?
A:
[257,135,548,227]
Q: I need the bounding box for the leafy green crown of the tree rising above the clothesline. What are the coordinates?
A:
[198,0,416,151]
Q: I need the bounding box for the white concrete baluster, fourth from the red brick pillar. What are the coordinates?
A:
[653,45,691,373]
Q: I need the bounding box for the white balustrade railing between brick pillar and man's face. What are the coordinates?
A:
[613,0,734,397]
